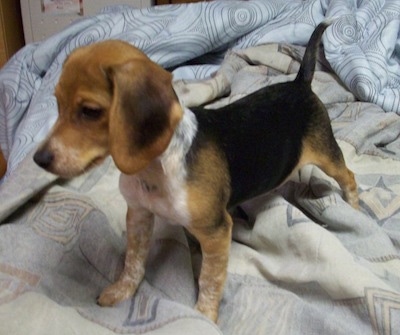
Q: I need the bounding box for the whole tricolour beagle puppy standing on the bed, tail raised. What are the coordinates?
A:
[34,23,358,321]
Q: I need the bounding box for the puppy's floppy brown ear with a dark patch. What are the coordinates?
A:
[107,58,183,174]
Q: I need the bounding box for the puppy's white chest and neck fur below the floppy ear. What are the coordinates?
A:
[116,110,197,226]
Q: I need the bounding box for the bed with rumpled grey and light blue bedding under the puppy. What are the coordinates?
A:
[0,0,400,335]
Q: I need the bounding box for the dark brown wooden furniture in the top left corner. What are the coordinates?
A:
[0,0,25,67]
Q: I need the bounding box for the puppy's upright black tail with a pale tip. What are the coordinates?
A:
[295,20,333,84]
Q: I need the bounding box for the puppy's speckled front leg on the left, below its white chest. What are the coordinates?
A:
[97,207,154,306]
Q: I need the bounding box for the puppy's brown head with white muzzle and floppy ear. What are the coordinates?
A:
[34,41,182,177]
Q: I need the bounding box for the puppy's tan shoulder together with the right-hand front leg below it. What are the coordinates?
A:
[188,146,232,321]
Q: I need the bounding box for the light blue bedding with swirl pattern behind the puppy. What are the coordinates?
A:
[0,0,400,178]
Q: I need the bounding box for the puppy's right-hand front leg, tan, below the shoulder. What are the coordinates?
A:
[190,211,232,322]
